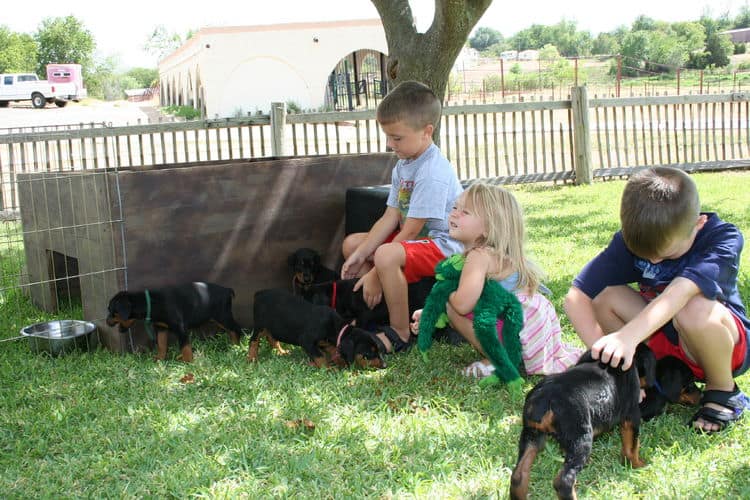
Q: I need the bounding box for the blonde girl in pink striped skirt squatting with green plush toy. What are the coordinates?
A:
[412,182,582,378]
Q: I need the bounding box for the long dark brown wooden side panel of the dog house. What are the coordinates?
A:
[119,154,395,325]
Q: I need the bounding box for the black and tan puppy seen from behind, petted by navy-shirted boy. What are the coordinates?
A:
[510,344,656,498]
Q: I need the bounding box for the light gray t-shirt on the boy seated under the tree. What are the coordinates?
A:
[386,144,463,257]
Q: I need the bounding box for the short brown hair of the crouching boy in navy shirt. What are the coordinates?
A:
[620,167,700,258]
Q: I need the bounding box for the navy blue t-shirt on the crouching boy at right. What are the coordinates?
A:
[573,213,750,341]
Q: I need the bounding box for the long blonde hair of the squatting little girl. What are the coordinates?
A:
[464,182,544,293]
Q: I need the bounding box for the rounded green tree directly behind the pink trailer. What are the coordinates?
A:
[34,16,96,76]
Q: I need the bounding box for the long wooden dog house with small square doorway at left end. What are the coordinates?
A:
[18,153,396,352]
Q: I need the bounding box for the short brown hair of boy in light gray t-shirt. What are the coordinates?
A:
[376,80,442,130]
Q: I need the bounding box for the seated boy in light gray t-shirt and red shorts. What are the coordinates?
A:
[341,81,463,352]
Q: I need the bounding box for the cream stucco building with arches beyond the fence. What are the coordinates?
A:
[159,19,387,118]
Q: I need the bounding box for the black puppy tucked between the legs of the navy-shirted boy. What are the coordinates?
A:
[640,356,701,420]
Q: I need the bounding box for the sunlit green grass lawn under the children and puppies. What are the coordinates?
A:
[0,172,750,499]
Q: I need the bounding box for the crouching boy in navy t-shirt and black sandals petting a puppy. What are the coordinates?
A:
[564,167,750,433]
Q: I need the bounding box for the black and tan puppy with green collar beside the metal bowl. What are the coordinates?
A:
[107,282,242,363]
